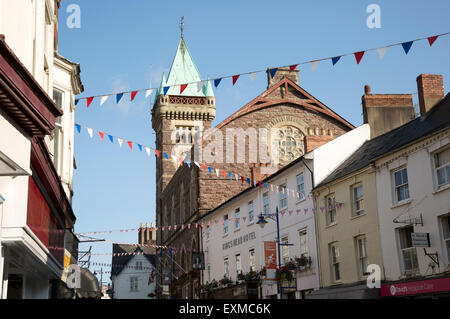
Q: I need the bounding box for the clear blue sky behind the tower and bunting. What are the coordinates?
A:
[59,0,450,281]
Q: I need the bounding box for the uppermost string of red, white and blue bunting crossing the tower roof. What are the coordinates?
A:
[75,32,450,107]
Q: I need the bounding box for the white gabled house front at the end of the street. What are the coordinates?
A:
[112,255,156,299]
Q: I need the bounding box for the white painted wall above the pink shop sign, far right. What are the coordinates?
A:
[376,131,450,280]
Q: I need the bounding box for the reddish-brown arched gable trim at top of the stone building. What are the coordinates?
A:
[216,77,355,129]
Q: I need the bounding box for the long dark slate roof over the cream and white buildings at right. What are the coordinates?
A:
[315,93,450,189]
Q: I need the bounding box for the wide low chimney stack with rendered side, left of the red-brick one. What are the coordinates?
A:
[361,84,415,138]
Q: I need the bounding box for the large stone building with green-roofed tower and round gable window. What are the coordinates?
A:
[152,38,354,298]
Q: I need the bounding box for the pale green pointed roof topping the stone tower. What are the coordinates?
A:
[162,37,214,96]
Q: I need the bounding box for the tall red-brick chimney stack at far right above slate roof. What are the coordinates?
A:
[416,74,444,116]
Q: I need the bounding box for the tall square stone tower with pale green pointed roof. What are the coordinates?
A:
[152,35,216,234]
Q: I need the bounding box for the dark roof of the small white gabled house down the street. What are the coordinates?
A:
[111,244,156,276]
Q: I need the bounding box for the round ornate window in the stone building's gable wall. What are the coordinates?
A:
[279,126,304,163]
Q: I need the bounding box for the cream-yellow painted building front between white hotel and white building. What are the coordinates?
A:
[313,164,383,298]
